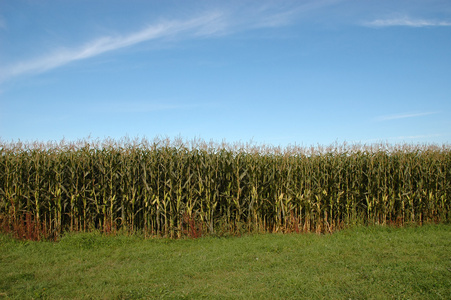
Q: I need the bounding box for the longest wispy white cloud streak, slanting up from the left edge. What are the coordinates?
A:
[0,0,338,82]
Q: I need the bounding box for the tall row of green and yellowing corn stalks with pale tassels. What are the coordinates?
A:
[0,139,451,238]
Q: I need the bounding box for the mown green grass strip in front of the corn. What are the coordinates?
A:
[0,225,451,299]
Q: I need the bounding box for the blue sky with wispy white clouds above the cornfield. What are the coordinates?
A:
[0,0,451,146]
